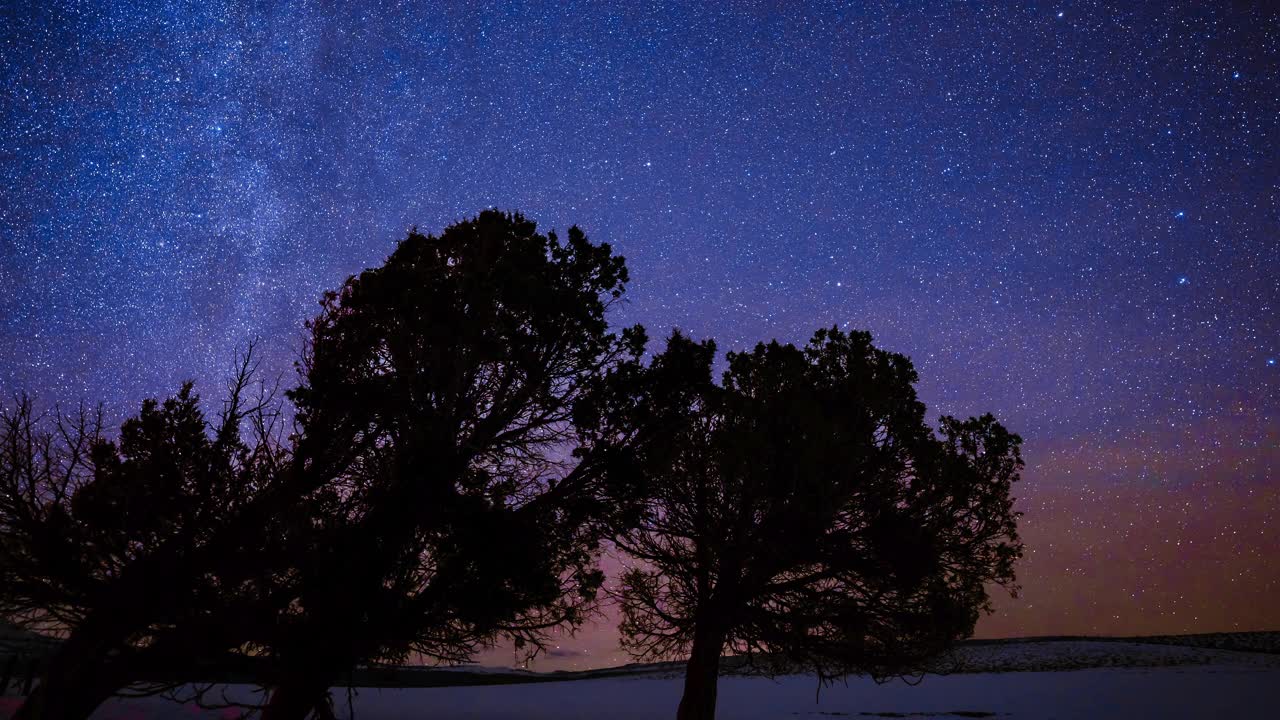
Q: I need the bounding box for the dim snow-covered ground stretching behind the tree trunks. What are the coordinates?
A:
[0,642,1280,720]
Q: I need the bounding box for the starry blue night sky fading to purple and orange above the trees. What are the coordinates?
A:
[0,0,1280,667]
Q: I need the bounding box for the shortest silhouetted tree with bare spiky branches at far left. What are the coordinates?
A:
[0,347,287,719]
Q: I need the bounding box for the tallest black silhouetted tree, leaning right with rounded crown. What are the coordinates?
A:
[254,211,644,720]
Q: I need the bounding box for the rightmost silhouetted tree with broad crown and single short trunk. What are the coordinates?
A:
[605,329,1021,720]
